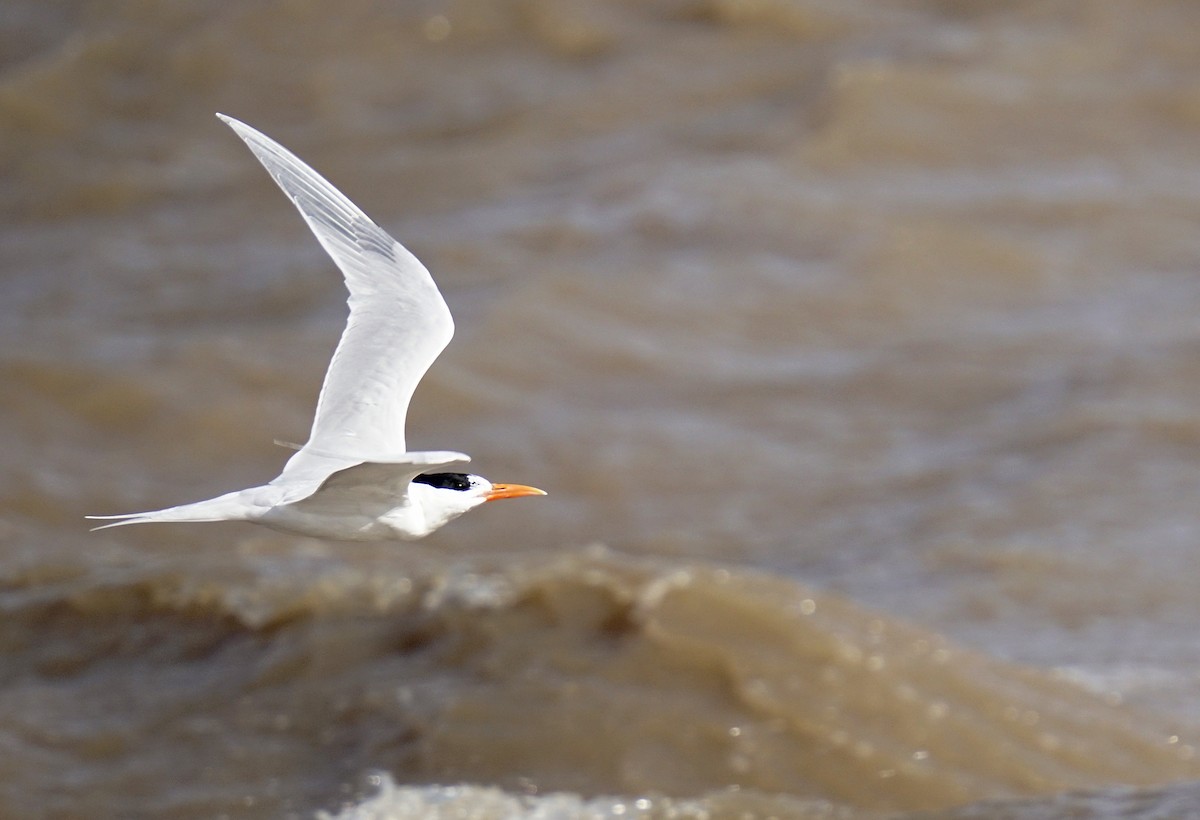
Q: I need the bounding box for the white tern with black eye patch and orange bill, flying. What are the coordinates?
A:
[88,114,546,540]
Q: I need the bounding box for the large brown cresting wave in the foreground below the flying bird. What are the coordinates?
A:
[0,547,1200,810]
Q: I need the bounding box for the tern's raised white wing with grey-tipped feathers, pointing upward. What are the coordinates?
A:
[217,114,454,483]
